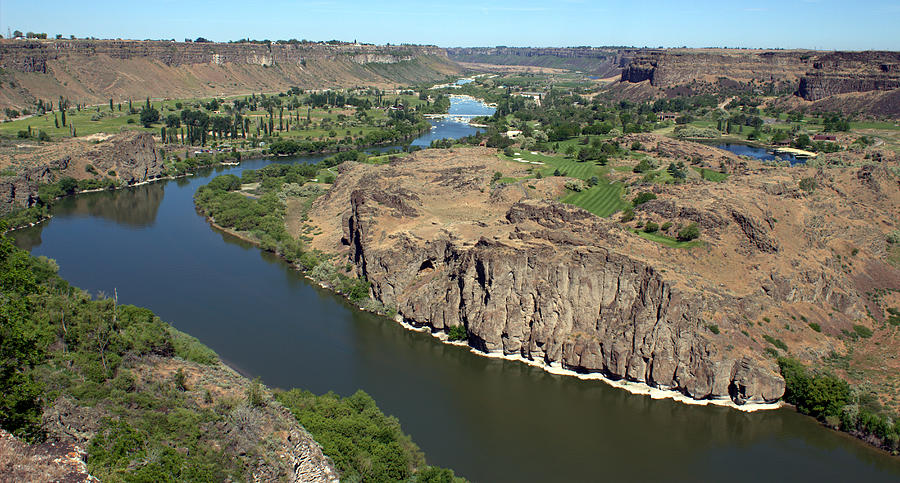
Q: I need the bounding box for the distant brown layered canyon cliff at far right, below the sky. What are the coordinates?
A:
[619,49,900,116]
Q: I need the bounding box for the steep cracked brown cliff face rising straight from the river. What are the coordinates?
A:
[347,194,784,403]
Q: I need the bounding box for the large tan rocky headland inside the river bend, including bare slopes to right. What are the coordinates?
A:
[310,147,900,405]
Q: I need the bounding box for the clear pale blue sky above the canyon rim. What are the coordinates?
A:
[0,0,900,50]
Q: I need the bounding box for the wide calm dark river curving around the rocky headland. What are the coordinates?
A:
[10,97,900,482]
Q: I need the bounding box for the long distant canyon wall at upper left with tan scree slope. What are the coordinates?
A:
[0,39,458,108]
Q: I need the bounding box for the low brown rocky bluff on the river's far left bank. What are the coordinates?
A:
[0,132,163,212]
